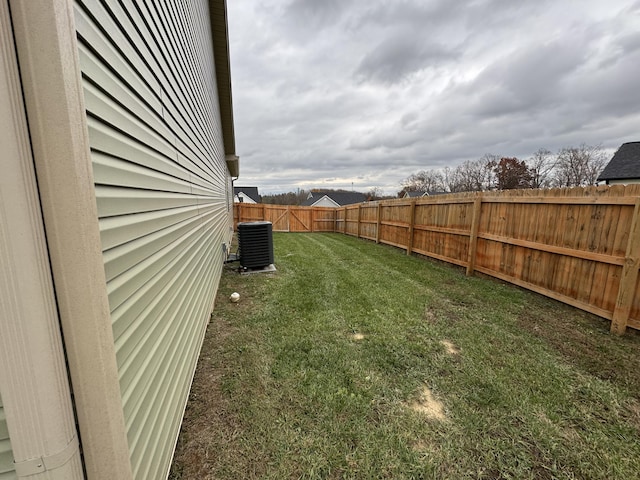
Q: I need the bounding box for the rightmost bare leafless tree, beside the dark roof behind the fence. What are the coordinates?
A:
[553,143,607,187]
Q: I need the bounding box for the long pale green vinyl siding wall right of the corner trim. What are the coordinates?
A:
[74,0,232,479]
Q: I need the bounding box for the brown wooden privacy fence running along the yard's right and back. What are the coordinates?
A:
[236,185,640,333]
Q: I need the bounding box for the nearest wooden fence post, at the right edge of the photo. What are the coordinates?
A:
[611,199,640,335]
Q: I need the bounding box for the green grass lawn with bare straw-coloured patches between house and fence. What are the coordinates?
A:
[170,234,640,480]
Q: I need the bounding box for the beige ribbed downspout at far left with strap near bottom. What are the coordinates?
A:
[0,0,85,480]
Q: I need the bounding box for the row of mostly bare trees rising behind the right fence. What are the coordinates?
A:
[398,144,608,196]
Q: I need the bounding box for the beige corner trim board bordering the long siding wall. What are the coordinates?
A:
[4,0,132,480]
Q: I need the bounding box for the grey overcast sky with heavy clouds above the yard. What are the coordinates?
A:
[227,0,640,194]
